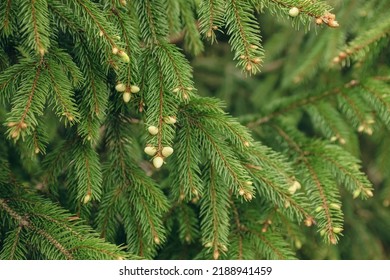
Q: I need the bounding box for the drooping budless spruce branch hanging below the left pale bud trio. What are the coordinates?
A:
[97,108,168,257]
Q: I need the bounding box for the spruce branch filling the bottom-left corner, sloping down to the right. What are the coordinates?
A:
[0,188,126,259]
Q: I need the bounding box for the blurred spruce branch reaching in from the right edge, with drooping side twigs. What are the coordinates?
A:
[247,79,389,145]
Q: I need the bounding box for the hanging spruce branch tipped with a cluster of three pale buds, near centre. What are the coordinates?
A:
[142,43,193,168]
